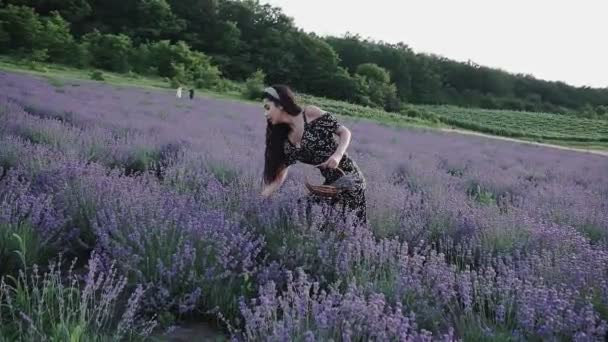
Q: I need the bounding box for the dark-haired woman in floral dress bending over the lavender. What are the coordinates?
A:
[262,85,367,224]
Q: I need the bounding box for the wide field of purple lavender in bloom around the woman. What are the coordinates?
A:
[0,72,608,341]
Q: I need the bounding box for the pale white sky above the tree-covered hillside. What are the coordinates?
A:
[260,0,608,88]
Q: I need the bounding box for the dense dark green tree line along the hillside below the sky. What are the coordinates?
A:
[0,0,608,118]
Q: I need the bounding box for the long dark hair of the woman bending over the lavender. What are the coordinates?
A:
[262,84,302,184]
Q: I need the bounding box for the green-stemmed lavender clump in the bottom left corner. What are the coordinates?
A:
[0,250,155,342]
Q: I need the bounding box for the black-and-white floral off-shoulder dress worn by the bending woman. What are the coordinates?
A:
[284,112,367,223]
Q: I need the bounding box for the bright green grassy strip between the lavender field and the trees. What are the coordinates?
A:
[0,56,608,150]
